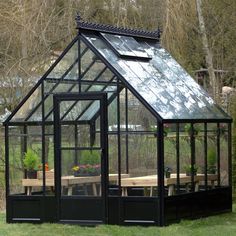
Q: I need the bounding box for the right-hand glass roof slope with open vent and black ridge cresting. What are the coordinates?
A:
[78,18,230,120]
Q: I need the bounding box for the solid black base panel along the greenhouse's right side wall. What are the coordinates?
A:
[164,187,232,225]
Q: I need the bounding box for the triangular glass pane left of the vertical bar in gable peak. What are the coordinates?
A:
[47,41,78,80]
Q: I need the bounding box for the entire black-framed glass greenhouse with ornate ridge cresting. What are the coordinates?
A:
[4,17,232,226]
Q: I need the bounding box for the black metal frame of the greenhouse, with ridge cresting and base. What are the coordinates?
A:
[4,16,232,226]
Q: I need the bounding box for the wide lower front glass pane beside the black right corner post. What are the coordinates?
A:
[121,134,157,197]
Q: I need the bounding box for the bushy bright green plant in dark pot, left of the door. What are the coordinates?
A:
[23,149,39,179]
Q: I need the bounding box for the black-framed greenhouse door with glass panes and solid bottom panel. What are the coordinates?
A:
[54,92,108,224]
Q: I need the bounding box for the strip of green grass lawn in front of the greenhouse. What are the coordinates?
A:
[0,206,236,236]
